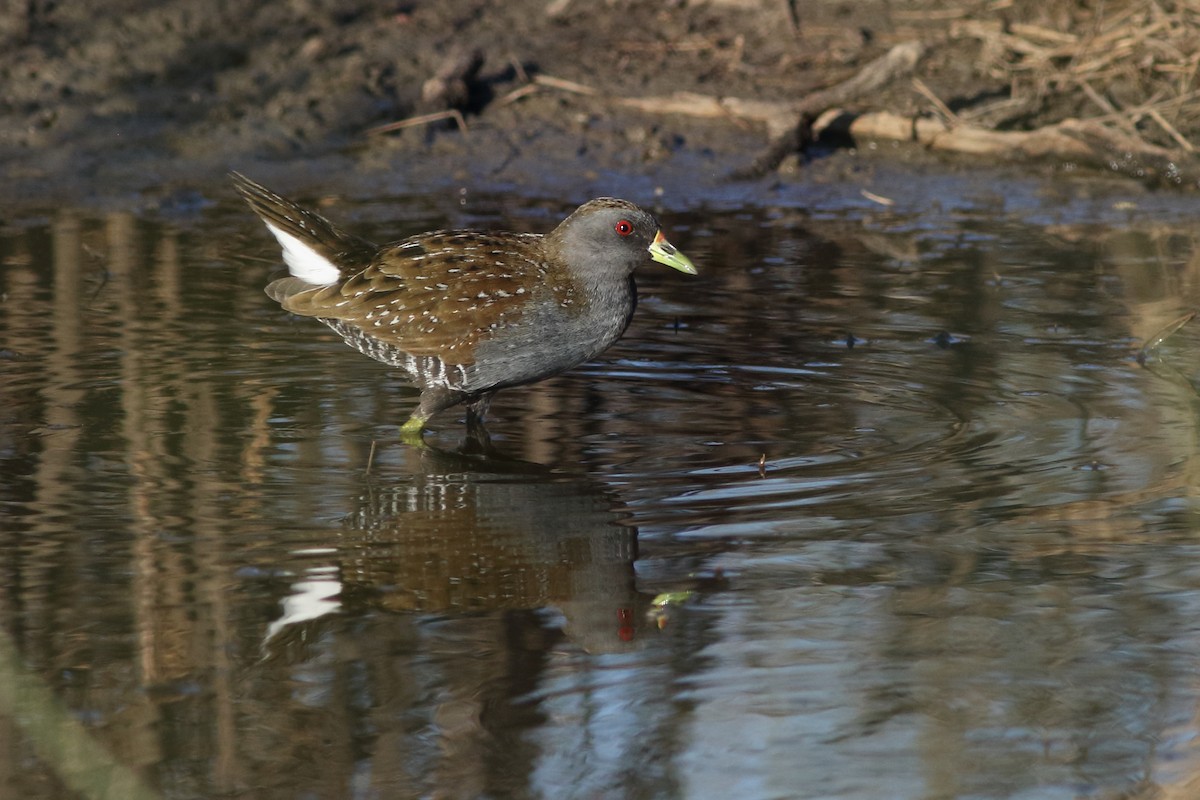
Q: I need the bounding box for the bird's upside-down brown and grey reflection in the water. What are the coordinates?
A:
[269,438,652,652]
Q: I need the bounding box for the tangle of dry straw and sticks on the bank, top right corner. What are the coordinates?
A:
[750,0,1200,190]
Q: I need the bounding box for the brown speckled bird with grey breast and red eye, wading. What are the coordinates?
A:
[230,172,697,441]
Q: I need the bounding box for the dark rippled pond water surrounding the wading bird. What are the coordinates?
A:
[0,172,1200,799]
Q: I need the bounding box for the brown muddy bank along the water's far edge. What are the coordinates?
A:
[0,0,1200,212]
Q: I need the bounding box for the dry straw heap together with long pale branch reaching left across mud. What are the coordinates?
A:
[374,0,1200,190]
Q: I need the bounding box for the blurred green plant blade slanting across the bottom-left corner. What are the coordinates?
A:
[0,631,160,800]
